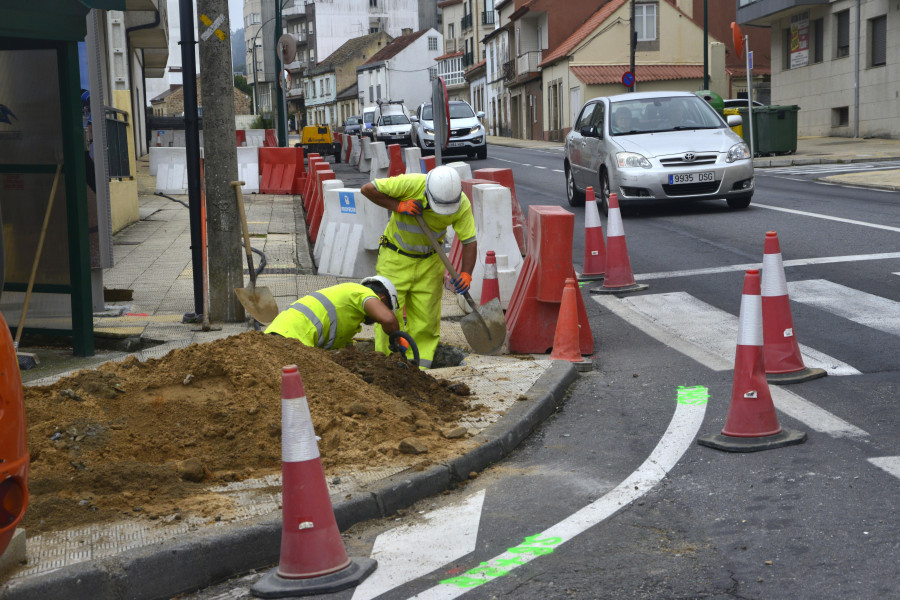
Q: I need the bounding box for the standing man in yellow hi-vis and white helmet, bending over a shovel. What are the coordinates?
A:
[362,166,478,369]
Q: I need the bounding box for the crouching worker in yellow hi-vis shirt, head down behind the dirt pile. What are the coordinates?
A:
[266,276,405,349]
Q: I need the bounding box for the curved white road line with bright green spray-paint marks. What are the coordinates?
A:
[413,396,706,600]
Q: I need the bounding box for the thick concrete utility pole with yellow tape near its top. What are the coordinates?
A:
[197,0,244,322]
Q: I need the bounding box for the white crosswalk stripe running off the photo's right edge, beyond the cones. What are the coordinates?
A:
[788,279,900,335]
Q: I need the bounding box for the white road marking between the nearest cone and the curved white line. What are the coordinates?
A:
[351,490,485,600]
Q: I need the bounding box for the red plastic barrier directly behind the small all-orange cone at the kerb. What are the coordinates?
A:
[506,206,594,354]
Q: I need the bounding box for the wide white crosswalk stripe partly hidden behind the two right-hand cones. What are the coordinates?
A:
[593,292,860,375]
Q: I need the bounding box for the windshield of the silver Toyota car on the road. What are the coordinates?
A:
[609,96,726,135]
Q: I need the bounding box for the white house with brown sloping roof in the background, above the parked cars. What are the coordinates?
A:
[356,29,444,110]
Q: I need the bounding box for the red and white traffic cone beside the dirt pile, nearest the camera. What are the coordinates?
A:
[250,365,378,598]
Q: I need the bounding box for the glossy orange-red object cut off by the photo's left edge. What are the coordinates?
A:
[0,314,29,554]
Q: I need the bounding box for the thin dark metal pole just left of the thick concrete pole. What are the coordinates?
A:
[178,0,203,315]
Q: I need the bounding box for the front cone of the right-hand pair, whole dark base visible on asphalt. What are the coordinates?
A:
[698,269,806,452]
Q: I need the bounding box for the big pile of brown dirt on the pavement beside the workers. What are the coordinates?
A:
[23,332,481,535]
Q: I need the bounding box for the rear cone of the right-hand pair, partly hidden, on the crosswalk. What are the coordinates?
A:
[762,231,826,384]
